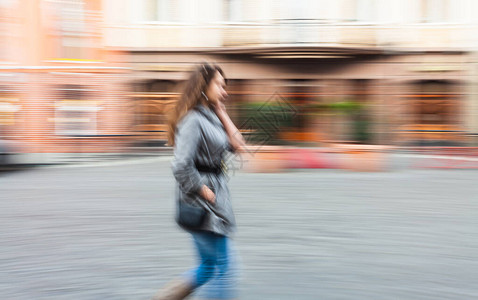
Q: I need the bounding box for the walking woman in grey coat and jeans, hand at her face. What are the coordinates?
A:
[153,64,244,300]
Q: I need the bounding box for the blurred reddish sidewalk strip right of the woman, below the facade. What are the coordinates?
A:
[241,144,478,172]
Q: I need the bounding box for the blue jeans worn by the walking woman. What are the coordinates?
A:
[187,231,241,299]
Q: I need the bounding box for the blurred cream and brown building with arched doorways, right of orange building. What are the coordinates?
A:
[105,0,478,144]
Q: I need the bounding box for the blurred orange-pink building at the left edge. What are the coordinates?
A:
[0,0,129,153]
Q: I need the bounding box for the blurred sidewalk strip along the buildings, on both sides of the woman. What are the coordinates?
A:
[9,144,478,173]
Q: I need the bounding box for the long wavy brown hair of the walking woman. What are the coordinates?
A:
[168,63,224,146]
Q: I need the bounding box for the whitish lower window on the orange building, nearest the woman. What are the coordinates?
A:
[55,85,100,136]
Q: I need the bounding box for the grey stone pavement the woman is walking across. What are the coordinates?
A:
[0,159,478,300]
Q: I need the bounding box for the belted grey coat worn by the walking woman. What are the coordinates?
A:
[172,105,236,236]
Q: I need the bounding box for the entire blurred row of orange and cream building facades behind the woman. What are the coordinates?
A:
[0,0,478,152]
